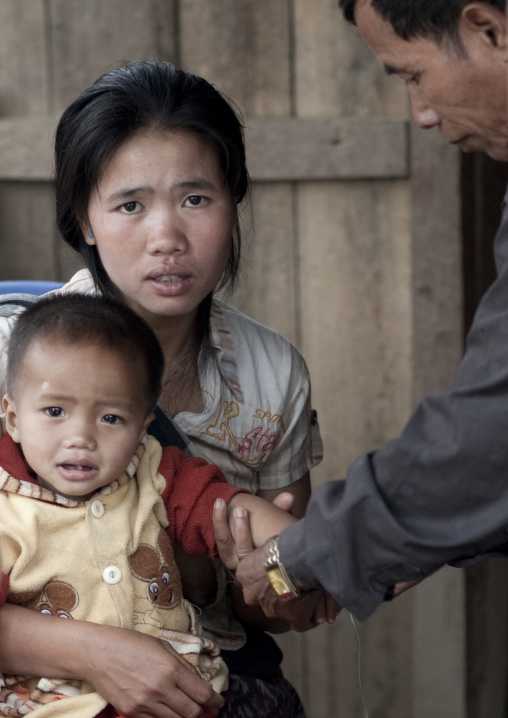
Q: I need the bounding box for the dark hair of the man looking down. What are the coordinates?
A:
[339,0,506,42]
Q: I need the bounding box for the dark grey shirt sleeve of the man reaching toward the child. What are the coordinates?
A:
[280,187,508,619]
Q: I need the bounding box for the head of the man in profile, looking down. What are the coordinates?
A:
[339,0,508,160]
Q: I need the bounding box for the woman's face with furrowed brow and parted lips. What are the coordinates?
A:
[86,130,235,329]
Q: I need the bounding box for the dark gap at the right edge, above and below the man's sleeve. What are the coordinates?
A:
[462,154,508,718]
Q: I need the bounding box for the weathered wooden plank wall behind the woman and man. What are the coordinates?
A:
[0,0,503,718]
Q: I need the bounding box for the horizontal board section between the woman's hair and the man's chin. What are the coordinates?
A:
[247,118,409,181]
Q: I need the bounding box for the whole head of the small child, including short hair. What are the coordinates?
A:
[3,295,164,500]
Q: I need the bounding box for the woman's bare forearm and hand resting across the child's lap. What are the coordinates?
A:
[0,604,224,718]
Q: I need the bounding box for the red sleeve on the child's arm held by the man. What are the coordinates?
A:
[159,446,249,557]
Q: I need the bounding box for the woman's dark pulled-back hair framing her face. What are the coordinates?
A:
[55,60,249,312]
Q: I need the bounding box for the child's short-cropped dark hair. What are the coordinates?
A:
[7,294,164,413]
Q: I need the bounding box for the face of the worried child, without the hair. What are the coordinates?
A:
[3,339,153,499]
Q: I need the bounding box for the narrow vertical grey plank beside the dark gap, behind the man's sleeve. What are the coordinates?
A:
[411,127,467,718]
